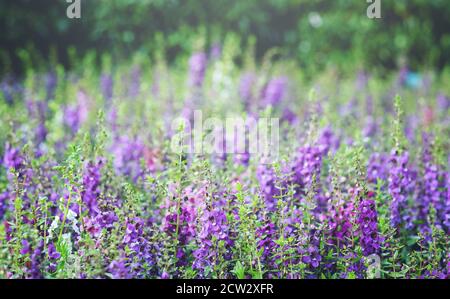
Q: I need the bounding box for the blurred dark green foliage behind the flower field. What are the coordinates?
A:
[0,0,450,73]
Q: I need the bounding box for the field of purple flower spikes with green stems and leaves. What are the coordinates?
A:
[0,35,450,279]
